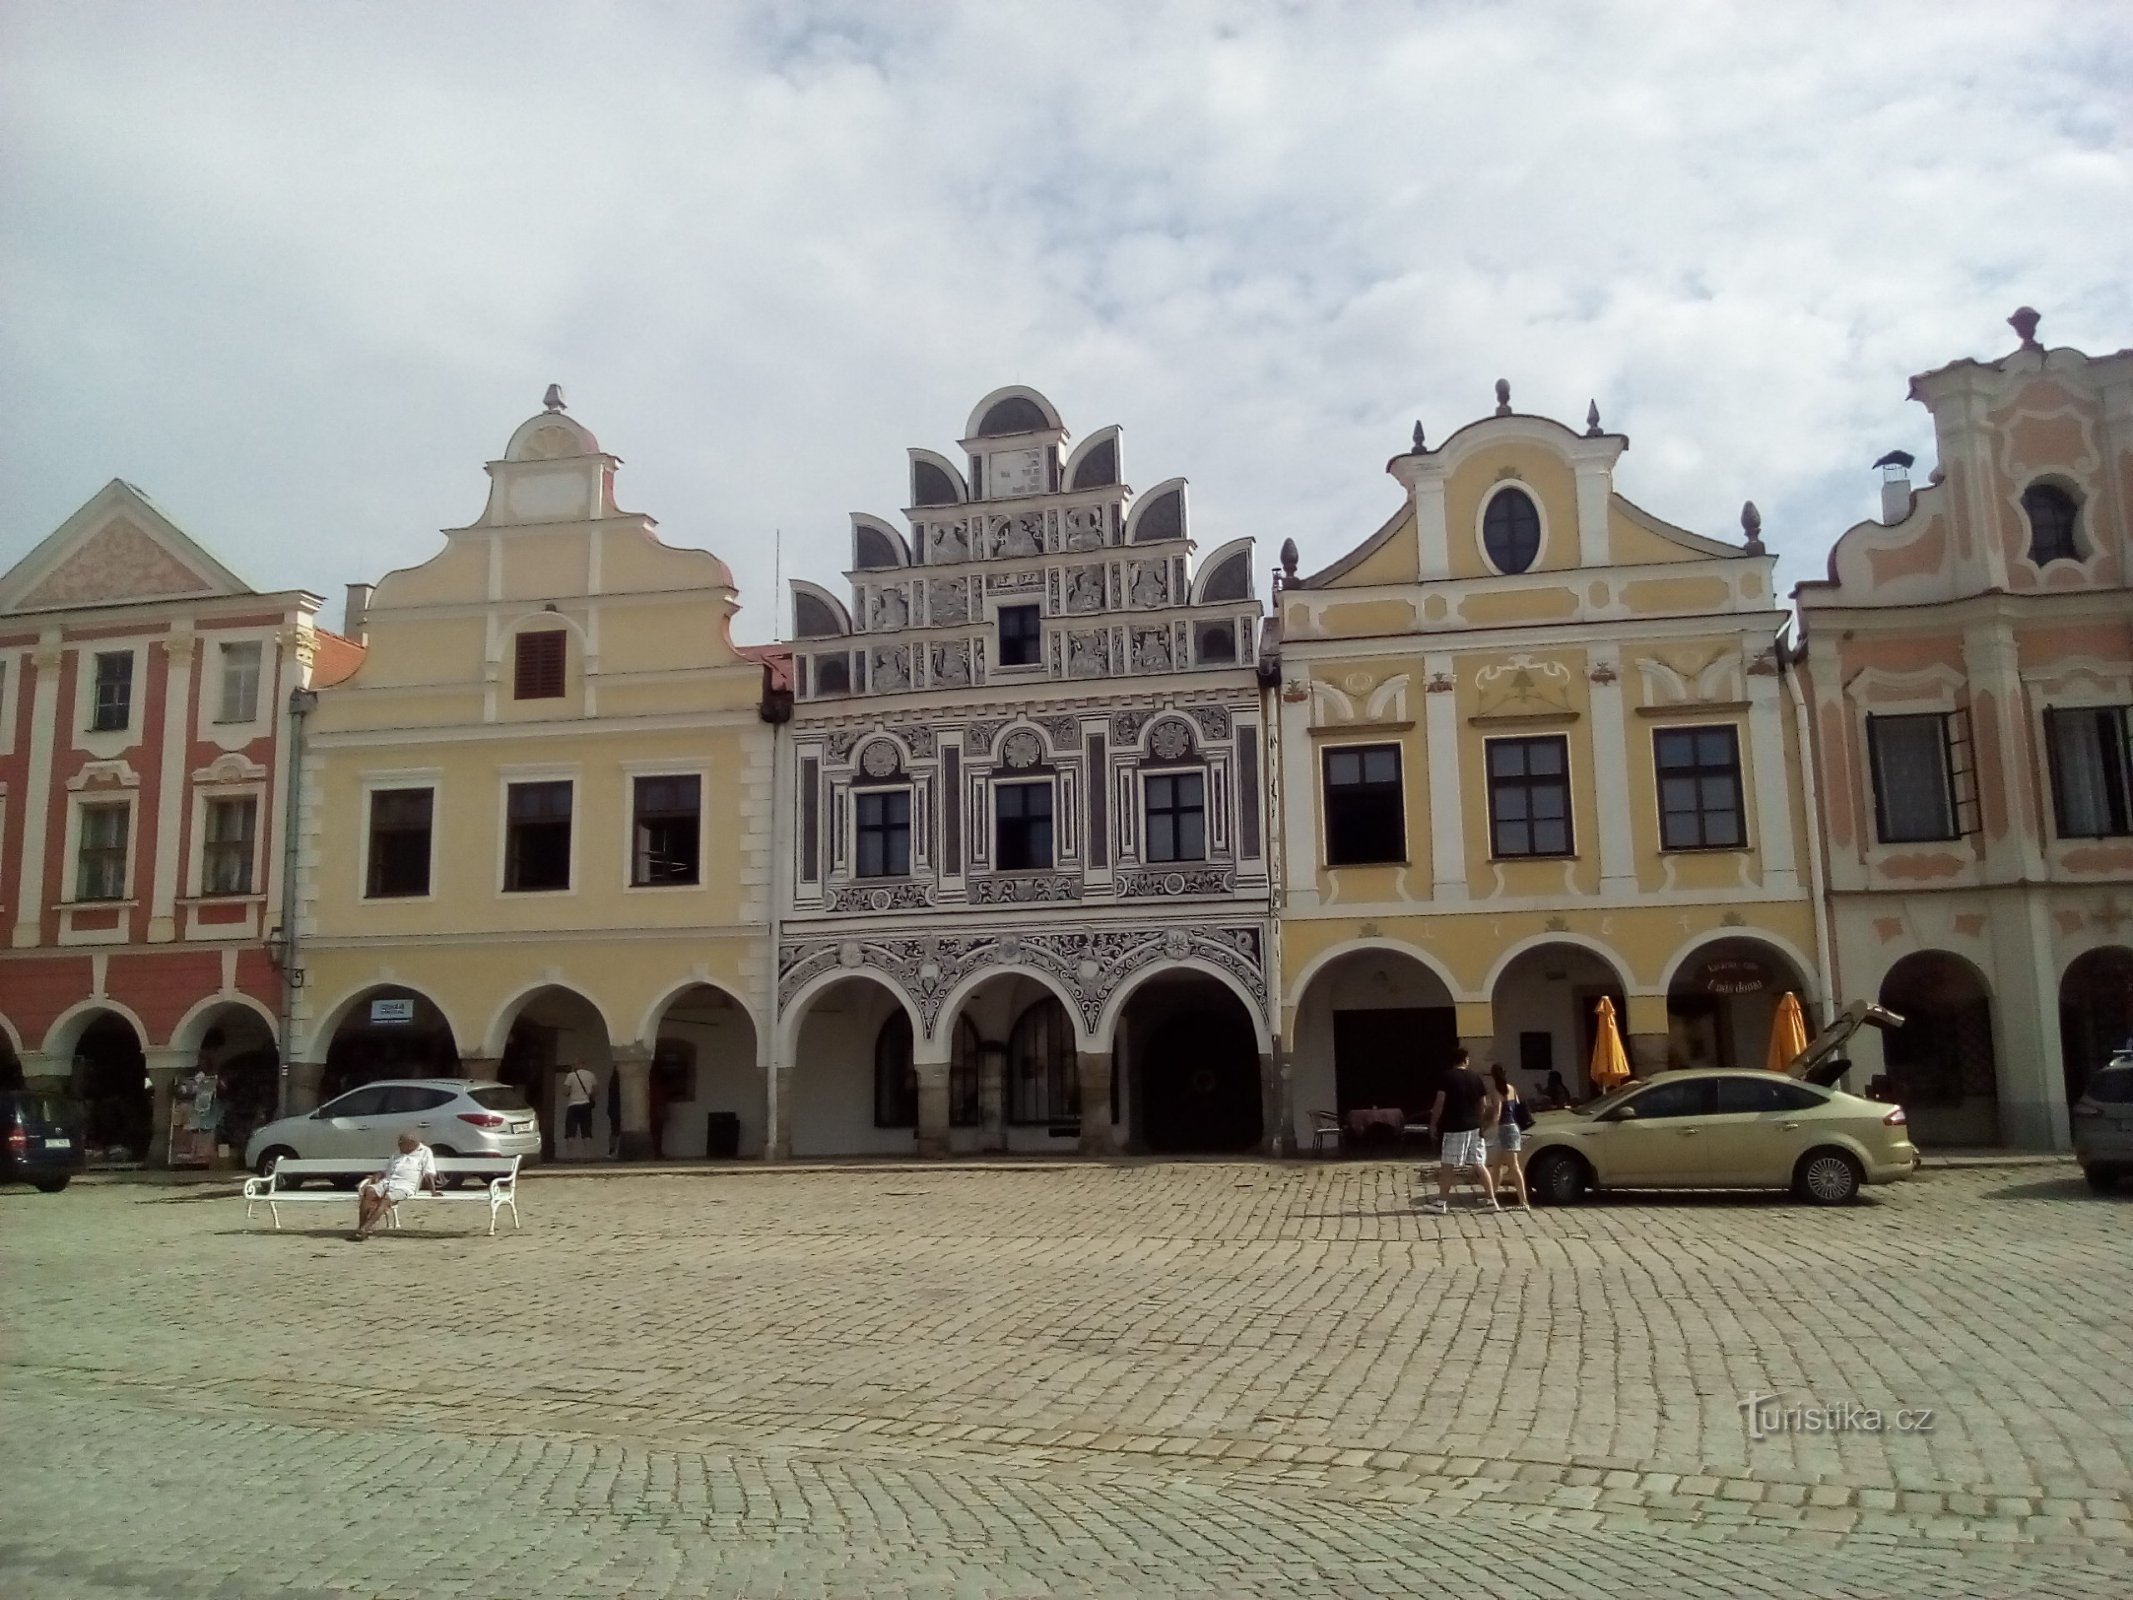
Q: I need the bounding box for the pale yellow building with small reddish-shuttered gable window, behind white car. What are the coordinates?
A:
[290,390,779,1156]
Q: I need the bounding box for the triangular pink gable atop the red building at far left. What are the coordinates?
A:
[0,478,252,612]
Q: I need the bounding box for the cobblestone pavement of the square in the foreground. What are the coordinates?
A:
[0,1163,2133,1600]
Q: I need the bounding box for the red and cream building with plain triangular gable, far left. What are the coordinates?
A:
[0,480,360,1165]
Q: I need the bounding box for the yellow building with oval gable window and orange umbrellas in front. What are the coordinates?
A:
[1278,384,1828,1135]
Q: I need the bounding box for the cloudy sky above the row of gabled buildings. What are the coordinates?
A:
[0,0,2133,638]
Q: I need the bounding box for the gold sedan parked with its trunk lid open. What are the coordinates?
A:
[1525,1069,1918,1205]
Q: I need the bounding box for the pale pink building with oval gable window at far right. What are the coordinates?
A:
[1796,307,2133,1148]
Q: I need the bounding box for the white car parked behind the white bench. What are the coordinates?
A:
[245,1077,540,1178]
